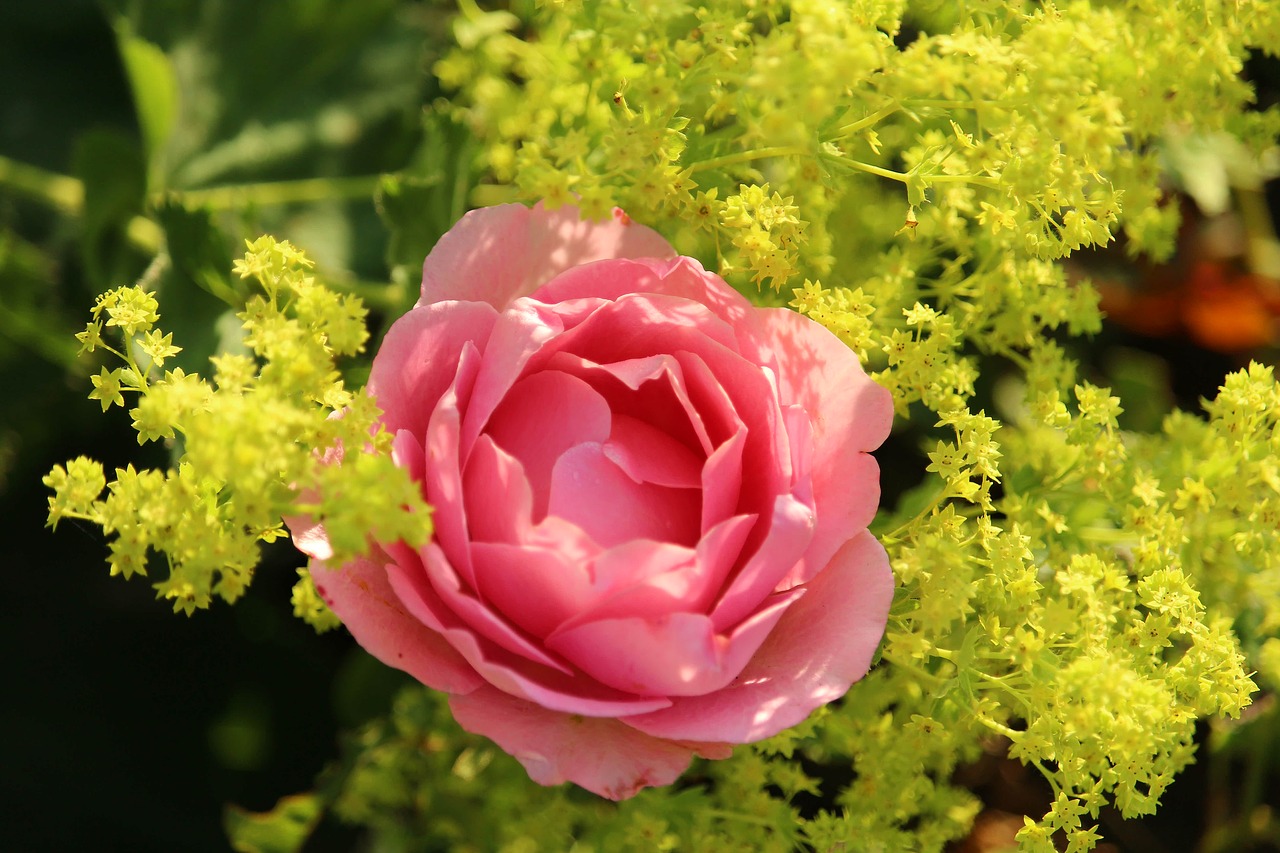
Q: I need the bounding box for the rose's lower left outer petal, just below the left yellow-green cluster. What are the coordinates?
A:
[311,552,484,693]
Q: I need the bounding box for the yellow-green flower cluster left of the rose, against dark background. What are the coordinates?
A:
[45,237,430,628]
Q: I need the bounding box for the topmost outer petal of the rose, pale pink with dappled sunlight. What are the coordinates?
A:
[417,204,676,311]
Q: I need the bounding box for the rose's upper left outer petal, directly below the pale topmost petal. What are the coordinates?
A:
[369,302,498,434]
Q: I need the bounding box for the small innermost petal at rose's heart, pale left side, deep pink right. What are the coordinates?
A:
[548,442,701,548]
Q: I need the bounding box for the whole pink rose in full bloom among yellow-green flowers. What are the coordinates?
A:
[294,205,893,799]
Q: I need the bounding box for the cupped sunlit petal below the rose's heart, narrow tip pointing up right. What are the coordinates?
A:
[547,588,805,697]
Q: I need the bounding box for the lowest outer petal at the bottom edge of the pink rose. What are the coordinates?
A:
[449,686,730,800]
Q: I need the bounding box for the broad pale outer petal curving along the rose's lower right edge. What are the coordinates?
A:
[622,530,893,743]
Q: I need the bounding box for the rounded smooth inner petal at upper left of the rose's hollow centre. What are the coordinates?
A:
[485,370,611,520]
